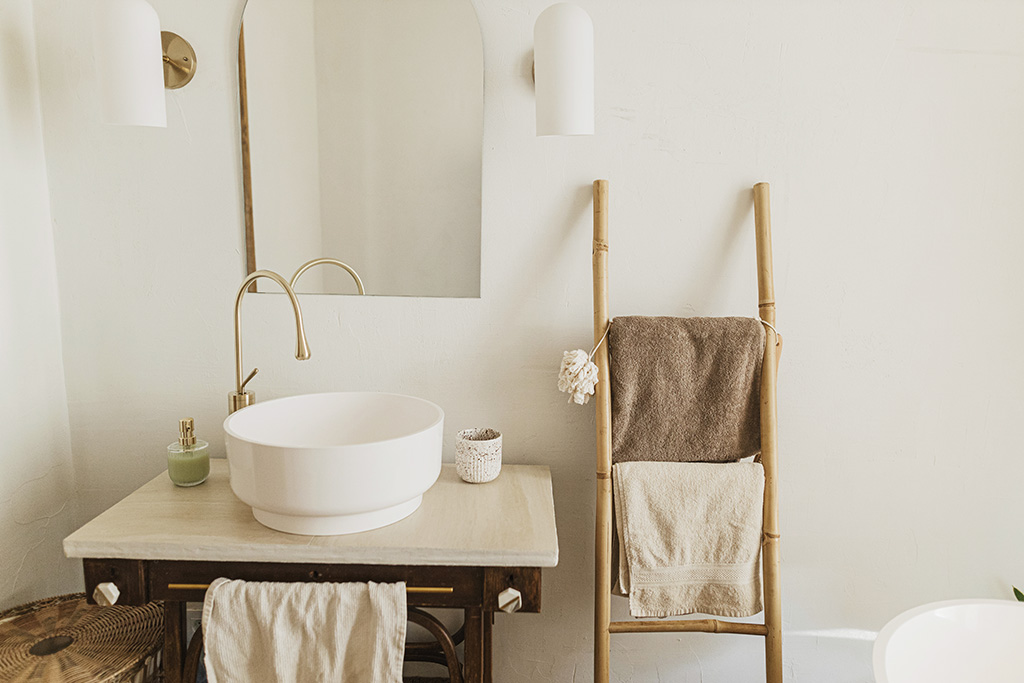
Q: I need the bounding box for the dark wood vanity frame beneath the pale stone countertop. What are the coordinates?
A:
[83,558,541,683]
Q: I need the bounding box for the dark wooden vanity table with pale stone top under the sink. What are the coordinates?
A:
[63,460,558,683]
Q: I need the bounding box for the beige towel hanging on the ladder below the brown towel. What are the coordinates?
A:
[611,463,765,616]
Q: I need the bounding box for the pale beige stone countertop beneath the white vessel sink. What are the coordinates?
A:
[63,460,558,567]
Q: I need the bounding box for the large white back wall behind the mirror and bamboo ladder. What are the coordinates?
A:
[28,0,1024,683]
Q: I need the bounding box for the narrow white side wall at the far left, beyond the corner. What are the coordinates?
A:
[0,0,82,610]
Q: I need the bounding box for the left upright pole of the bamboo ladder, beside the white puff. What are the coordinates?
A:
[593,180,612,683]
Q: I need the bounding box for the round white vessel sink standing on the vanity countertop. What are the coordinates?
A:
[224,392,444,536]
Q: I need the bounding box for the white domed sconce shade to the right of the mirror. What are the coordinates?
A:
[534,2,594,135]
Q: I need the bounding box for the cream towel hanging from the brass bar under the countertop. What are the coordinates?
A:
[203,579,407,683]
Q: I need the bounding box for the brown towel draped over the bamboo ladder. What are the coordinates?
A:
[608,315,765,463]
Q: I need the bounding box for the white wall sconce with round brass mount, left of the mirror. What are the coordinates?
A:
[93,0,196,128]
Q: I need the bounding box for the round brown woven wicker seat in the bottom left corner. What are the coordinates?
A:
[0,593,164,683]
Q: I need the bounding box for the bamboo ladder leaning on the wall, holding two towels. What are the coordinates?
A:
[593,180,782,683]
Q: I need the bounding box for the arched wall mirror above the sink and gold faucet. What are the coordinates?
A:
[239,0,483,297]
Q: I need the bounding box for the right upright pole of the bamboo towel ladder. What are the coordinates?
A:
[754,182,782,683]
